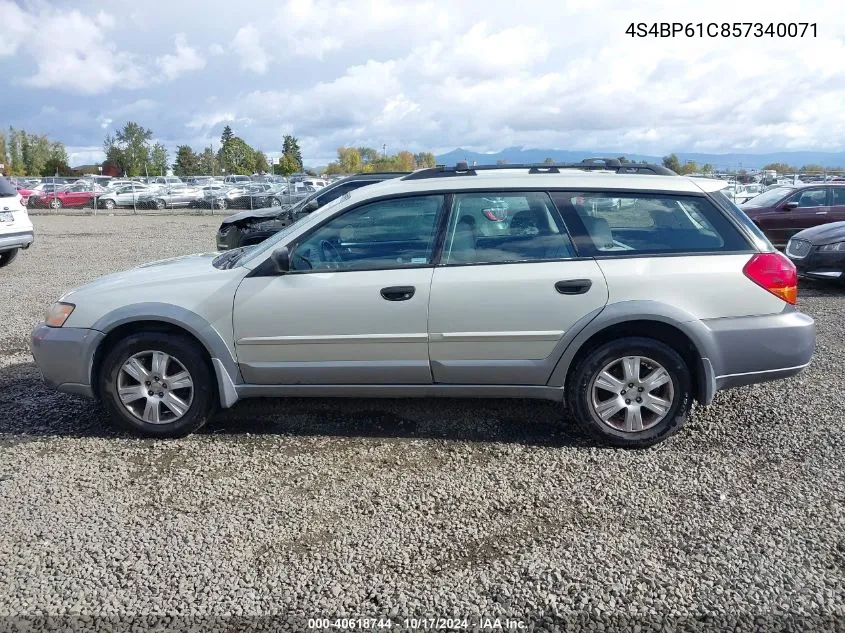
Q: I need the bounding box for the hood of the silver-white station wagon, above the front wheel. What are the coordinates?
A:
[62,253,224,300]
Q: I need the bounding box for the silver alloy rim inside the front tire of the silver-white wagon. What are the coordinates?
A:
[117,350,194,424]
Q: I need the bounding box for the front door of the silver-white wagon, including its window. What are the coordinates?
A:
[227,195,443,385]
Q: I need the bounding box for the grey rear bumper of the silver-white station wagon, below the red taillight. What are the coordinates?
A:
[704,306,816,391]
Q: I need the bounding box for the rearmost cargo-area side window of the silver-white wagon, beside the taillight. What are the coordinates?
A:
[553,191,749,256]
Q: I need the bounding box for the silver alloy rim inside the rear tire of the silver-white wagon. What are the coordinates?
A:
[590,356,675,433]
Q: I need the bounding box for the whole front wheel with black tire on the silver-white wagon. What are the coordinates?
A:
[98,332,217,437]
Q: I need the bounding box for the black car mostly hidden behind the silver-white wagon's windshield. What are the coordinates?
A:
[217,172,407,250]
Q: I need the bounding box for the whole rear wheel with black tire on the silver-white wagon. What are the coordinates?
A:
[567,337,692,448]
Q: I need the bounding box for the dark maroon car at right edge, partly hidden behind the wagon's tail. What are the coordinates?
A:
[740,183,845,247]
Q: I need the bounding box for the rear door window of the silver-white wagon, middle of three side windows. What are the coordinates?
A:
[442,191,575,265]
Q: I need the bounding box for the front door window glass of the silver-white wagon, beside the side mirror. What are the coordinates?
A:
[291,196,443,270]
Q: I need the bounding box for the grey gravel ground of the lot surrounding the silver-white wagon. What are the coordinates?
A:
[0,216,845,631]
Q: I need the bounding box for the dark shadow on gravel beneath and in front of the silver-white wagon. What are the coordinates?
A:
[0,362,597,447]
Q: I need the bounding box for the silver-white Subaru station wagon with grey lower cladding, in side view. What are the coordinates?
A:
[32,159,815,447]
